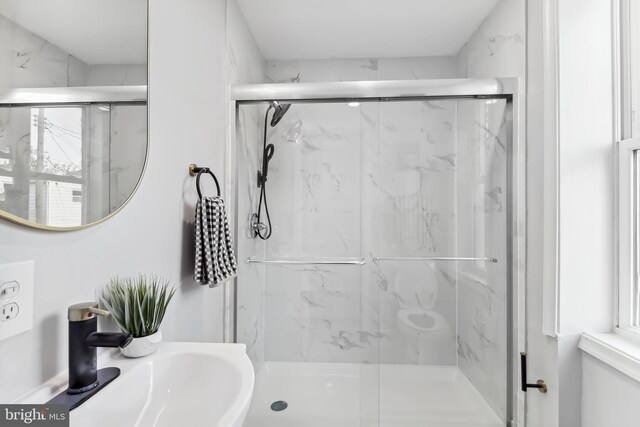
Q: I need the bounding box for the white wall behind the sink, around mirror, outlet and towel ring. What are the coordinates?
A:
[0,0,226,402]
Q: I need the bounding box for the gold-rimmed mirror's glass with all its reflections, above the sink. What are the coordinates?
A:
[0,0,147,229]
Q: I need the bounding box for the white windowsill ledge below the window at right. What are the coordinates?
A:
[579,333,640,382]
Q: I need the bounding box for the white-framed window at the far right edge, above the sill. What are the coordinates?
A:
[617,0,640,338]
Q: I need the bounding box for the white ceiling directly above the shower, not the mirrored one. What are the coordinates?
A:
[237,0,498,60]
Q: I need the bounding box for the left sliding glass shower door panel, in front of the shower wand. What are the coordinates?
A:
[237,99,380,427]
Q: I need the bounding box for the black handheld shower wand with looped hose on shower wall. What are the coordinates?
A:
[251,101,291,240]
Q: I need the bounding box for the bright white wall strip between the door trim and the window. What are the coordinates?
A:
[558,0,615,427]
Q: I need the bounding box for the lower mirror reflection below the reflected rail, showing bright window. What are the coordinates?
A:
[0,103,146,227]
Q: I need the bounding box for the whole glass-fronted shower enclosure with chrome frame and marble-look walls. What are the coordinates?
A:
[228,79,523,427]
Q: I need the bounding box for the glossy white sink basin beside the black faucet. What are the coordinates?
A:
[20,342,254,427]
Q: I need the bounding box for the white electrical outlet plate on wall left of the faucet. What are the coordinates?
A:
[0,261,35,340]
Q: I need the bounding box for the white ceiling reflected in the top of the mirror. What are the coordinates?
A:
[0,0,147,64]
